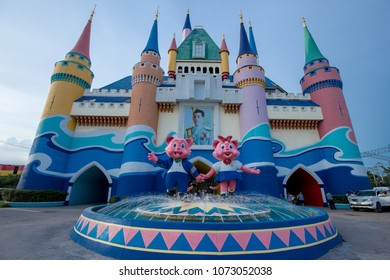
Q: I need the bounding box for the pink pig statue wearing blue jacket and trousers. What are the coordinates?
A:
[148,136,204,196]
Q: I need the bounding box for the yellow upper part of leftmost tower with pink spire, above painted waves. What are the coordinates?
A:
[42,10,95,130]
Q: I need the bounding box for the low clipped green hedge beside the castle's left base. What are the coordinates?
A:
[2,189,68,202]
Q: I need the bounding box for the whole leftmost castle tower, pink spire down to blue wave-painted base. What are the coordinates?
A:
[18,11,95,190]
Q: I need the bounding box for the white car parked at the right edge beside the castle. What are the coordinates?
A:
[348,187,390,213]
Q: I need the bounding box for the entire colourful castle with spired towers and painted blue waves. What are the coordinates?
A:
[18,9,369,206]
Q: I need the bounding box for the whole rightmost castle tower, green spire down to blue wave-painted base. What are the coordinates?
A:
[300,18,369,194]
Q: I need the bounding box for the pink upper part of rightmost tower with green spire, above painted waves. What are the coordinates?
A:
[300,19,356,143]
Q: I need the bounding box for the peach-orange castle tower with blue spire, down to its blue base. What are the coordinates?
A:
[115,12,164,196]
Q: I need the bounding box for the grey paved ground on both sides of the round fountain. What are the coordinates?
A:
[0,205,390,260]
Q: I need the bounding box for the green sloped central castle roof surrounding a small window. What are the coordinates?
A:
[176,28,221,60]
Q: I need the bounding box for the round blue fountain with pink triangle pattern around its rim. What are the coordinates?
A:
[71,194,341,259]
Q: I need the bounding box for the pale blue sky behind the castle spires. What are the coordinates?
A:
[0,0,390,167]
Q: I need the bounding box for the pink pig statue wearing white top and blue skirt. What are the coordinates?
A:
[204,136,260,196]
